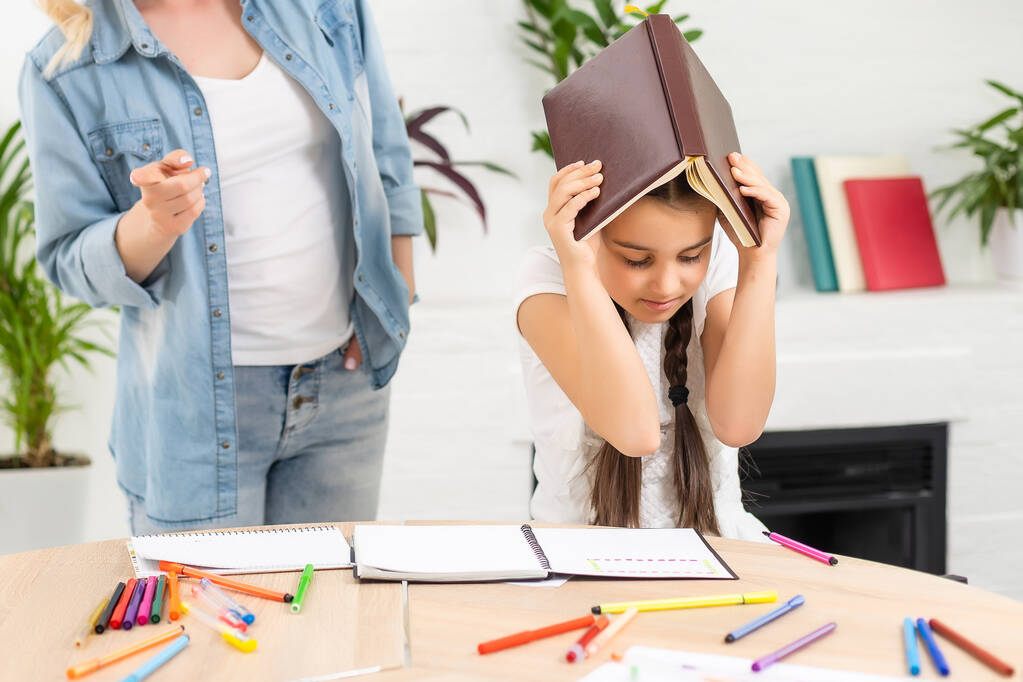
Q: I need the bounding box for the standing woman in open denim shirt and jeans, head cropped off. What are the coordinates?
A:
[20,0,422,534]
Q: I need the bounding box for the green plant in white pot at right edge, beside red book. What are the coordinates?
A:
[931,81,1023,281]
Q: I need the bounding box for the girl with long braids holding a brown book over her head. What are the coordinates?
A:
[517,153,789,540]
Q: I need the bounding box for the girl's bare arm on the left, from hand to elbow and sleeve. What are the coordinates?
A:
[518,166,661,456]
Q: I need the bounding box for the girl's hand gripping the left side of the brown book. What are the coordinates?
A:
[543,161,604,268]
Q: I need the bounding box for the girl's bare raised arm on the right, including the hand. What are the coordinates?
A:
[701,156,789,447]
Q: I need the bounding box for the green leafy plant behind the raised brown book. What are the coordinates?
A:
[519,0,703,157]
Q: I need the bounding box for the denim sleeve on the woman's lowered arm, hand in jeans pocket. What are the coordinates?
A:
[356,0,424,236]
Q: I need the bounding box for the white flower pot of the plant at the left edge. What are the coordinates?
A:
[0,465,91,554]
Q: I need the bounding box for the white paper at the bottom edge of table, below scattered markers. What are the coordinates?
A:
[579,646,918,682]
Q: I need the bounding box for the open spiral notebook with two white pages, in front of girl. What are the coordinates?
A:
[352,525,738,583]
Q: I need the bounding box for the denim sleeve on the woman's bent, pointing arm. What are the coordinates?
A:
[19,57,168,308]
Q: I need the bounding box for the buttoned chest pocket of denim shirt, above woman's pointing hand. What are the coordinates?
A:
[89,119,164,211]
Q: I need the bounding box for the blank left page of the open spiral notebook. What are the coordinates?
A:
[352,526,541,577]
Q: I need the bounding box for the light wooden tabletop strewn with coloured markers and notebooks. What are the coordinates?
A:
[0,524,1023,682]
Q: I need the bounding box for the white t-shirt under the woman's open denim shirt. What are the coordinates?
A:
[194,53,355,365]
